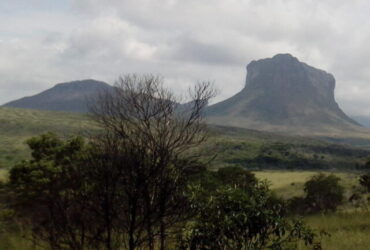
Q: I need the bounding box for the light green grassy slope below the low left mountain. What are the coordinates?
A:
[0,108,93,168]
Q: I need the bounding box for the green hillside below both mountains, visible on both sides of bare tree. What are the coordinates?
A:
[0,108,370,169]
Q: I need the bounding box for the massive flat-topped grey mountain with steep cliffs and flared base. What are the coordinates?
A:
[207,54,360,134]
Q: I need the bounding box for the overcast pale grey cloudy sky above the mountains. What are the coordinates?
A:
[0,0,370,116]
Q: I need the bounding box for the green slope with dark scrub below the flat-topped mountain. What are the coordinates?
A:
[202,127,369,170]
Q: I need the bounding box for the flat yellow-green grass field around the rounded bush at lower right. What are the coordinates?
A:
[255,171,370,250]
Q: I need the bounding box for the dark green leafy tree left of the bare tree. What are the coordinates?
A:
[5,134,91,249]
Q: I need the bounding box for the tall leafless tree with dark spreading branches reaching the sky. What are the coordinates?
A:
[90,75,215,249]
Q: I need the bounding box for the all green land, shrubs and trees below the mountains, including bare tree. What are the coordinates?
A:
[0,76,370,249]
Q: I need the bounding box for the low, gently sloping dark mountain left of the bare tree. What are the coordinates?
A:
[3,79,112,113]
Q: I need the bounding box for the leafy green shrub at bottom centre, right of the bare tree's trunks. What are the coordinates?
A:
[179,183,315,250]
